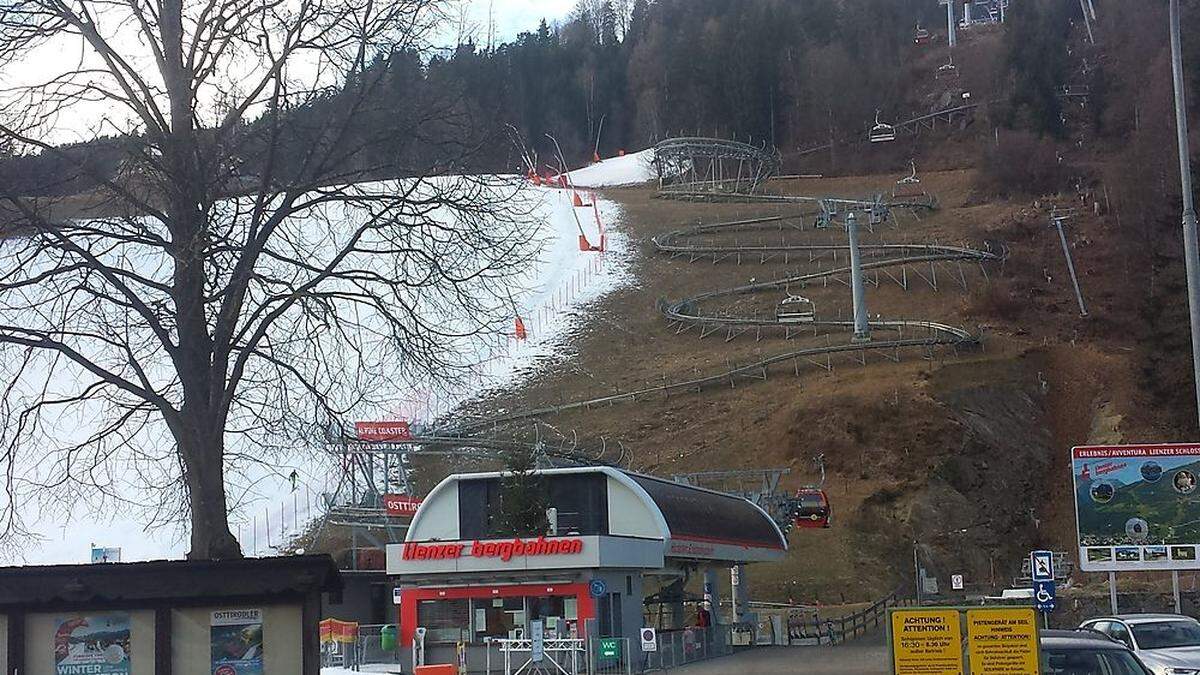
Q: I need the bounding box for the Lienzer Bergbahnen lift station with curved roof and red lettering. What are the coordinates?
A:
[386,467,787,663]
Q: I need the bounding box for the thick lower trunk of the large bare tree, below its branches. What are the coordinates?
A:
[176,425,242,560]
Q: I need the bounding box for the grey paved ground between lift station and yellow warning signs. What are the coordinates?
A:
[670,643,889,675]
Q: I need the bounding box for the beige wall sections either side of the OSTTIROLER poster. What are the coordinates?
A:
[171,604,304,675]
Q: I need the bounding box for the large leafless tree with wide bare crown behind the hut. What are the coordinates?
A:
[0,0,532,558]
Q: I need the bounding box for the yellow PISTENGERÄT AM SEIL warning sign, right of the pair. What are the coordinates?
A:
[967,607,1038,675]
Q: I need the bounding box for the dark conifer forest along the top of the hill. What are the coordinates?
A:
[0,0,1180,195]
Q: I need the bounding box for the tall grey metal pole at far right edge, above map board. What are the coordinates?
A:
[1171,0,1200,429]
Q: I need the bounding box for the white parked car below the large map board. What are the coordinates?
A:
[1080,614,1200,675]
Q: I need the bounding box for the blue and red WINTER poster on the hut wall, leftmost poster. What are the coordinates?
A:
[54,614,130,675]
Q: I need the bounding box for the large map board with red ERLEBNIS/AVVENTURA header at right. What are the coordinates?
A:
[1070,443,1200,572]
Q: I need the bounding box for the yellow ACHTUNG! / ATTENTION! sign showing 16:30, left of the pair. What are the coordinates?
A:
[892,609,962,675]
